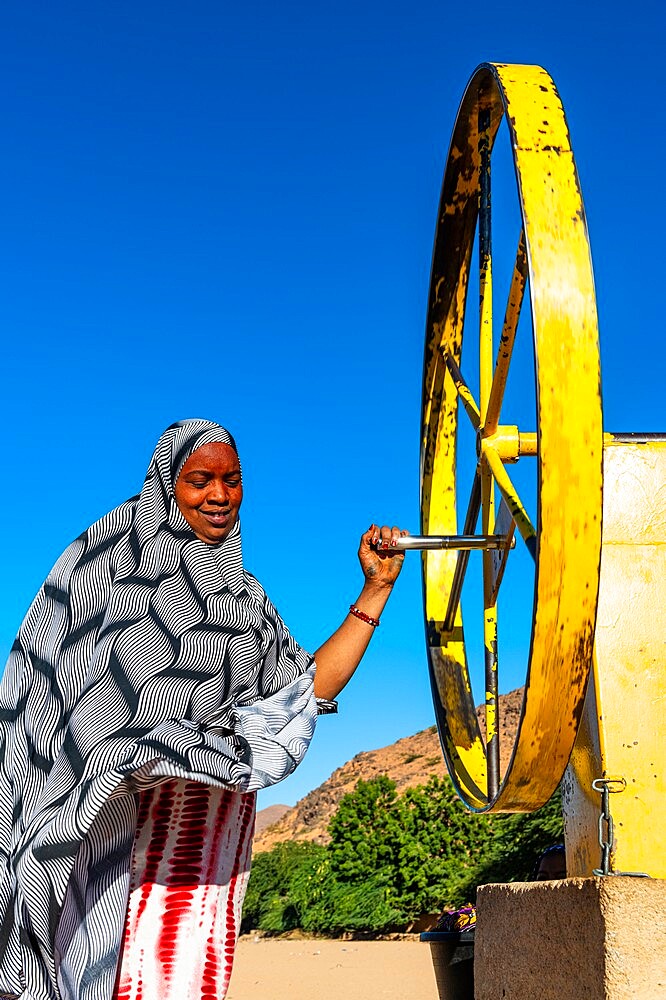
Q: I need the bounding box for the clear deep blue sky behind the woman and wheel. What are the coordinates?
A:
[0,0,666,805]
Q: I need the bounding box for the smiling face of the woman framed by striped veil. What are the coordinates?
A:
[174,441,243,545]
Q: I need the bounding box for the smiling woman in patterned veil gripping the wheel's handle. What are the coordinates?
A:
[0,420,402,1000]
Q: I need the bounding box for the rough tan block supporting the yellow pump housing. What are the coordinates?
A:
[474,876,666,1000]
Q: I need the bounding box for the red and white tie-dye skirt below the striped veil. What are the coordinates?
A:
[114,781,255,1000]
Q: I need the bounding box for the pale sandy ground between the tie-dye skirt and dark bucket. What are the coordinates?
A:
[227,935,438,1000]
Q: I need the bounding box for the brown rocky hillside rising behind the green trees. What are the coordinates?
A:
[254,688,523,853]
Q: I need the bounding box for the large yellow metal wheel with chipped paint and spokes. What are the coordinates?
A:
[421,64,603,812]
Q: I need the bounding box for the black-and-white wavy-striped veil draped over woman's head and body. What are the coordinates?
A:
[0,420,317,1000]
